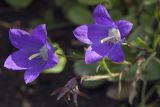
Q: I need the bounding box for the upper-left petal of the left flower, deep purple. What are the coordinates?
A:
[9,29,43,49]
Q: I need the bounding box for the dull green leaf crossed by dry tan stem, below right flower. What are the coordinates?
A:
[74,61,106,88]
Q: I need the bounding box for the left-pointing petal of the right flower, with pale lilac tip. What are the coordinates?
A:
[74,24,111,44]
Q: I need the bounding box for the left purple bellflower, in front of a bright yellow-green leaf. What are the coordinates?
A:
[4,24,58,84]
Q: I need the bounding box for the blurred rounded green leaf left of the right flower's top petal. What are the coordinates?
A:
[67,6,92,24]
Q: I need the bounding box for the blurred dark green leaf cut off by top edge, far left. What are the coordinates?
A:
[5,0,32,8]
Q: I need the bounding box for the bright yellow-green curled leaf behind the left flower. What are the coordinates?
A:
[43,44,67,73]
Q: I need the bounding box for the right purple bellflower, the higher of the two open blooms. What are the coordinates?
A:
[73,4,133,64]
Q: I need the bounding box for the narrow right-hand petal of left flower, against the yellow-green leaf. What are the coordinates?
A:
[46,43,58,68]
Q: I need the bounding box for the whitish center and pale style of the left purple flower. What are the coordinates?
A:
[28,45,48,61]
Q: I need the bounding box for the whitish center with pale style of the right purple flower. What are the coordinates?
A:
[100,28,121,43]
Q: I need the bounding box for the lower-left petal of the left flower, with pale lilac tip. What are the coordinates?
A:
[4,49,42,70]
